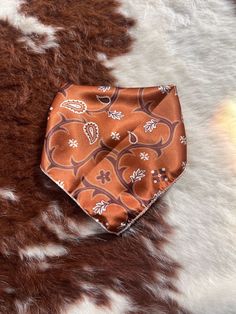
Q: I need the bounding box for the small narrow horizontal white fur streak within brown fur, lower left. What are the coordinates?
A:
[19,244,68,260]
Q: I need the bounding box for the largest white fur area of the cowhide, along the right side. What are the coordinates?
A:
[109,0,236,314]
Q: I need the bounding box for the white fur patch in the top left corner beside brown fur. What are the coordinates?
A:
[0,0,59,53]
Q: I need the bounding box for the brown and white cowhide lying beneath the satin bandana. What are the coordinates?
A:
[0,0,236,314]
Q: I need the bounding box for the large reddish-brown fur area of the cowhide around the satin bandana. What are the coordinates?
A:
[0,0,188,314]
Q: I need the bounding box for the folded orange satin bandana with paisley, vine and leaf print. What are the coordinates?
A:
[41,83,186,234]
